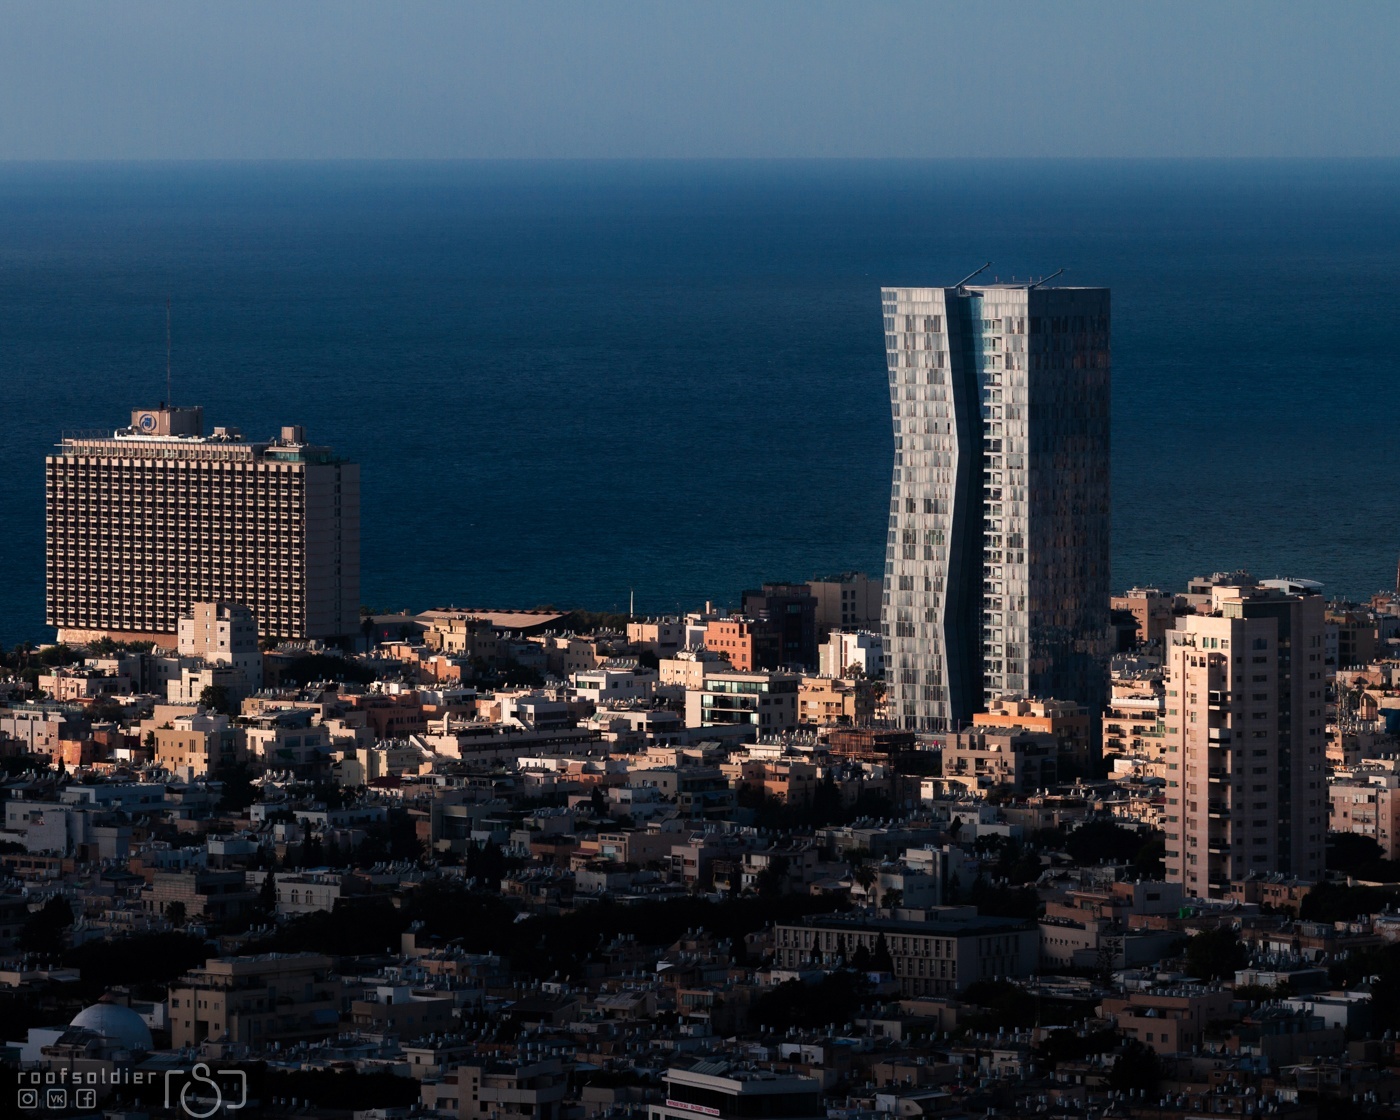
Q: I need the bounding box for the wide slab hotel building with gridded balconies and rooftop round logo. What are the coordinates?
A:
[46,407,360,645]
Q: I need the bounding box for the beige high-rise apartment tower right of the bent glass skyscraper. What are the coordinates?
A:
[1163,581,1327,897]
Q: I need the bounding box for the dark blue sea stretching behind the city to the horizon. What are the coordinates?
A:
[0,161,1400,644]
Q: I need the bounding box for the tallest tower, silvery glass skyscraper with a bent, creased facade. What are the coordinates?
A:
[881,284,1110,731]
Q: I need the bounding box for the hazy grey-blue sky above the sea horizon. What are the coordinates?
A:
[0,0,1400,160]
